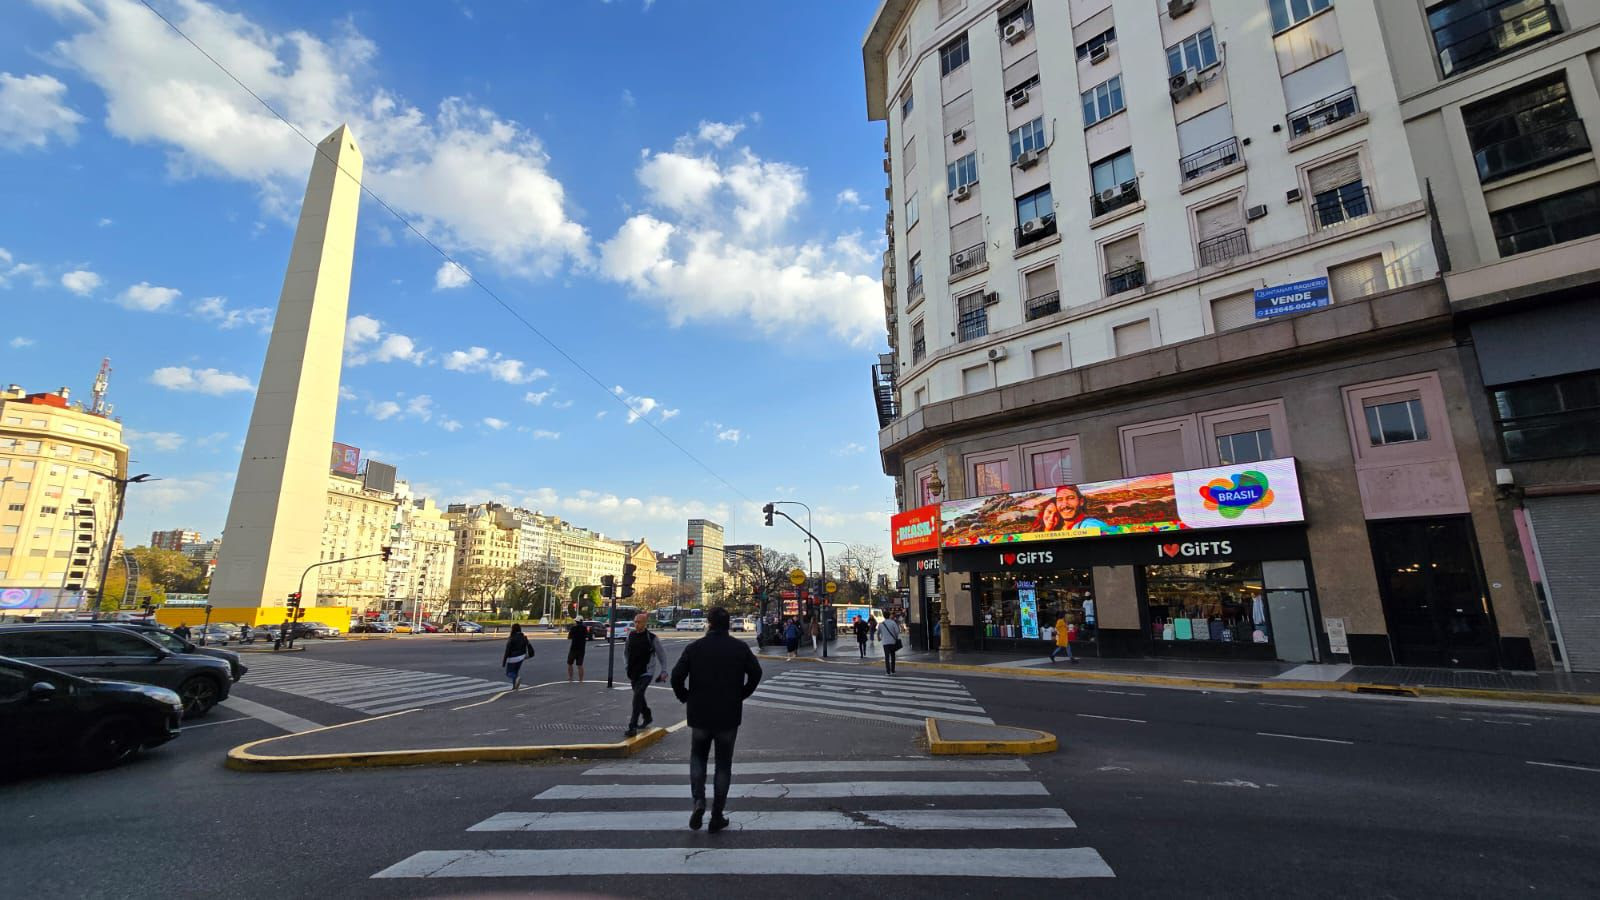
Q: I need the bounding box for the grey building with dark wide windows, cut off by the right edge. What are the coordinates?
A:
[1378,0,1600,673]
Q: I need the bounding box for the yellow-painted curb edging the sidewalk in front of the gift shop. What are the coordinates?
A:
[798,657,1600,706]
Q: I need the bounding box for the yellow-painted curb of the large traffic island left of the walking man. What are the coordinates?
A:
[226,709,667,772]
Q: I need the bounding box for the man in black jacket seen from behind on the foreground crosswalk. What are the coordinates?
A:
[672,607,762,833]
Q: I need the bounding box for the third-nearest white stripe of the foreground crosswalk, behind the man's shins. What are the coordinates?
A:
[533,781,1050,801]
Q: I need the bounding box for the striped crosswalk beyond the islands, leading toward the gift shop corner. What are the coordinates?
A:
[746,665,994,727]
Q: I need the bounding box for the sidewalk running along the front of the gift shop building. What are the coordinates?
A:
[762,641,1600,706]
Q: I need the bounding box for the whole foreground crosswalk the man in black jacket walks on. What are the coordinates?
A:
[373,757,1115,877]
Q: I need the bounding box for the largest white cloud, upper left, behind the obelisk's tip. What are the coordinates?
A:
[45,0,589,274]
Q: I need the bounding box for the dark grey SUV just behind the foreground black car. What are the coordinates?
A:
[0,623,234,716]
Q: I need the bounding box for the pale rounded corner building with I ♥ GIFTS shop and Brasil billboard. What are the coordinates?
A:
[862,0,1550,668]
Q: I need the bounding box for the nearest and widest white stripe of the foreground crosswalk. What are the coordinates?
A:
[373,846,1117,879]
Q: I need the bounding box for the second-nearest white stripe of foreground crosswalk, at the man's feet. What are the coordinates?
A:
[467,809,1077,831]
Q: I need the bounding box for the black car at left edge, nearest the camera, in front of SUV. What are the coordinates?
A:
[0,646,184,769]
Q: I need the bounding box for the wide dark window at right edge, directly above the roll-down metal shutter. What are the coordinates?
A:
[1493,372,1600,461]
